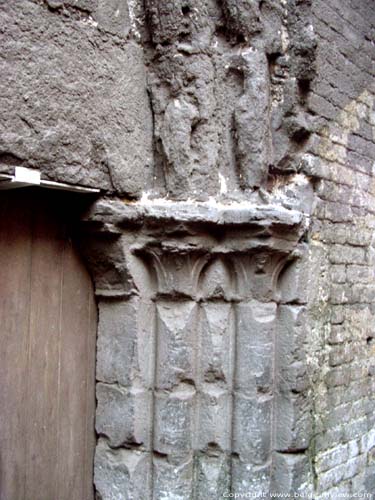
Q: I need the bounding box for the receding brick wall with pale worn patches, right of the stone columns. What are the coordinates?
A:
[305,0,375,499]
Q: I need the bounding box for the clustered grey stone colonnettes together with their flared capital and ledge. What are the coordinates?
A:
[80,197,307,499]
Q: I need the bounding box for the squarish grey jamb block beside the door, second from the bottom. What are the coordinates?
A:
[96,384,152,450]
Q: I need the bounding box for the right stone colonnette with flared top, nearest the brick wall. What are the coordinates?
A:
[232,253,279,494]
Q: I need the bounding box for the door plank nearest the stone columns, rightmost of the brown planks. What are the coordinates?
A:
[59,239,95,500]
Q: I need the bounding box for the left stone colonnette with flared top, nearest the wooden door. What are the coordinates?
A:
[147,251,210,498]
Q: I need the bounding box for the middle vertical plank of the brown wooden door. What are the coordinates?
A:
[25,204,64,500]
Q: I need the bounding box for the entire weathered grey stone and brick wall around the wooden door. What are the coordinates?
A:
[0,0,375,500]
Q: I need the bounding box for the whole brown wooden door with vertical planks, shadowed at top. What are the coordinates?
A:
[0,189,96,500]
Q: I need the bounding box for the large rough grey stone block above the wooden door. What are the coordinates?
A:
[0,0,152,196]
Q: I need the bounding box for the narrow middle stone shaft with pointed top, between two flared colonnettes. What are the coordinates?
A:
[194,258,234,500]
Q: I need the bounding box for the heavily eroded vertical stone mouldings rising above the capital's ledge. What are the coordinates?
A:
[146,0,315,199]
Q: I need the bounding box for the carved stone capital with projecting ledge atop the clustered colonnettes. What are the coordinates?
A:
[83,199,307,300]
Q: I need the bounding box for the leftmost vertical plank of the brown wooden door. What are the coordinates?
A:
[0,196,31,500]
